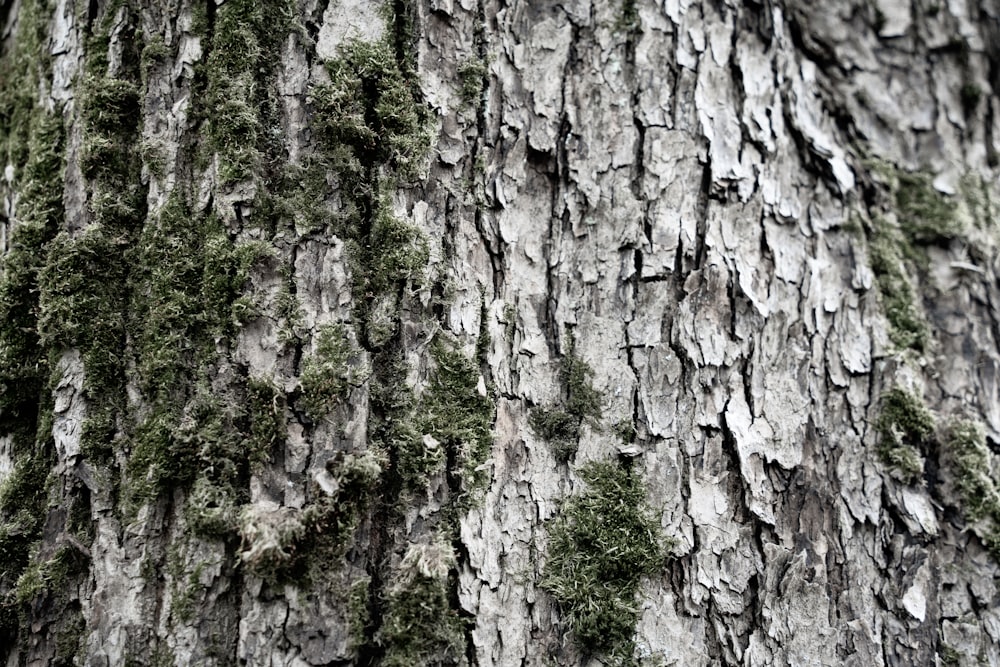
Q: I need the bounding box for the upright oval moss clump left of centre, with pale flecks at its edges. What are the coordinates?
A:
[414,340,496,493]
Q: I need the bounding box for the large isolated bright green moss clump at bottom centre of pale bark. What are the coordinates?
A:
[541,462,667,662]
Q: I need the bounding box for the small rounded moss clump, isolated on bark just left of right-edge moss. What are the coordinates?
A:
[875,387,934,484]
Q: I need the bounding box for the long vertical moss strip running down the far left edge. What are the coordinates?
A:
[0,109,64,646]
